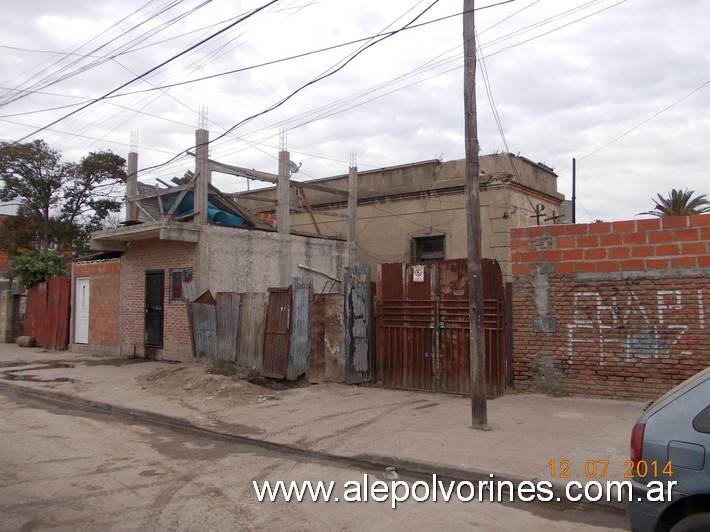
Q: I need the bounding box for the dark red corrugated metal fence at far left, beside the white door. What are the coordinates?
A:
[25,275,71,350]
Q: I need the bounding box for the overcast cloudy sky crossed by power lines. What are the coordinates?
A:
[0,0,710,222]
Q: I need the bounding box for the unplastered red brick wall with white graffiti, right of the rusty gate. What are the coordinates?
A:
[511,215,710,399]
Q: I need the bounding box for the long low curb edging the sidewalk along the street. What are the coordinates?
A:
[0,382,625,512]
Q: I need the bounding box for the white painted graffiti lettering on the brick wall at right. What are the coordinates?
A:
[567,288,706,365]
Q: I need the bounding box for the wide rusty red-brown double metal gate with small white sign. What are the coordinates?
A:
[377,259,506,396]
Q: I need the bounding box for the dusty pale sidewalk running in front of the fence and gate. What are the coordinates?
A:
[0,344,645,508]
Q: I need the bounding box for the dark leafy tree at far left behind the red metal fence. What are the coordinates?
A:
[0,140,126,256]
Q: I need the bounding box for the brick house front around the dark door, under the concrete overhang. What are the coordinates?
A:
[121,240,198,360]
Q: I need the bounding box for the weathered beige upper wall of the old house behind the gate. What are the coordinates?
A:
[239,154,564,281]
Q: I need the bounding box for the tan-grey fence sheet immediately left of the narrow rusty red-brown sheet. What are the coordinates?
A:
[237,292,268,372]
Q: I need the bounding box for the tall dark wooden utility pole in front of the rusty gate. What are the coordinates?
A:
[463,0,488,430]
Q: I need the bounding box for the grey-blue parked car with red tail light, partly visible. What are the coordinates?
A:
[626,368,710,532]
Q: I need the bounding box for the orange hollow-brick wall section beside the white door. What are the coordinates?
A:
[74,259,121,348]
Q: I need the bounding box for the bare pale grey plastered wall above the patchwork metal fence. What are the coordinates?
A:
[199,225,350,293]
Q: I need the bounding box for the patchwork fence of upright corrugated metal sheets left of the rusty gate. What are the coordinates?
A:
[185,268,371,383]
